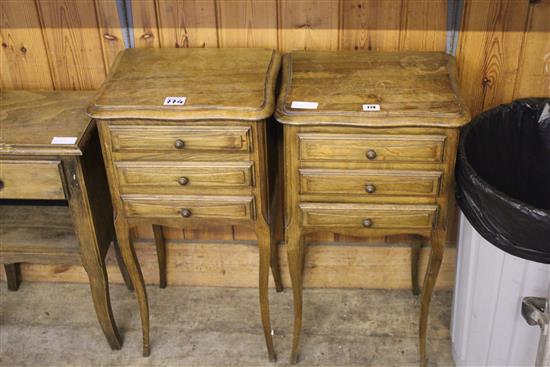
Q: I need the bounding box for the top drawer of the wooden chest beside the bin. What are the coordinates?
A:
[298,133,446,163]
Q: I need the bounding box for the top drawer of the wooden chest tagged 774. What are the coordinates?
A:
[110,125,252,153]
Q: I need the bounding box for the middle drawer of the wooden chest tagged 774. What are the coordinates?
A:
[115,161,254,194]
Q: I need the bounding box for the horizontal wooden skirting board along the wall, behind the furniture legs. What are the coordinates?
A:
[0,241,456,289]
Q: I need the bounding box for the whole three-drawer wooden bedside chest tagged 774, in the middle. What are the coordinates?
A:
[89,49,282,360]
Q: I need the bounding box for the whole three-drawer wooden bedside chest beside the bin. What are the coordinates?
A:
[275,51,469,363]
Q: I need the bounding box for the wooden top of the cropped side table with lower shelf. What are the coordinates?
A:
[0,91,94,155]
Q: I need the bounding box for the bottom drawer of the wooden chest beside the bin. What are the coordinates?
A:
[300,203,437,229]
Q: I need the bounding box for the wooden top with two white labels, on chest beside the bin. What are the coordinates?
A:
[275,51,470,127]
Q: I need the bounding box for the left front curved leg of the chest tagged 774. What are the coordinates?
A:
[115,217,151,357]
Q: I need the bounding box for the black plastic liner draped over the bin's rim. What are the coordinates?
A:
[455,98,550,264]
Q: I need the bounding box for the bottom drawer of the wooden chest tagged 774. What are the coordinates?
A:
[122,195,255,224]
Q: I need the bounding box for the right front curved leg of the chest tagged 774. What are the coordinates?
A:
[256,223,277,362]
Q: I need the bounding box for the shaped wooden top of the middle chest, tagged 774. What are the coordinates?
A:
[88,48,280,120]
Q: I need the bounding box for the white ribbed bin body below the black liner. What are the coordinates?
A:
[451,213,550,367]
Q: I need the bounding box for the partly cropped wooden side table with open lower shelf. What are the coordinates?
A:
[0,91,131,349]
